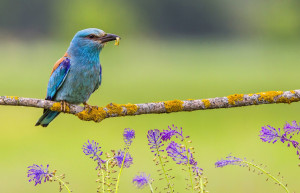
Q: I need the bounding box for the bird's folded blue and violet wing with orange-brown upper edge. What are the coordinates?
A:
[46,53,71,100]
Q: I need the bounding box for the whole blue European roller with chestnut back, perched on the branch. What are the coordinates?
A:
[35,28,120,127]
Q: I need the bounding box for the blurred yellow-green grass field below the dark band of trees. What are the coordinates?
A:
[0,38,300,193]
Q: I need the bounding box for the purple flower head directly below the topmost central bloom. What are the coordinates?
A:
[166,141,188,164]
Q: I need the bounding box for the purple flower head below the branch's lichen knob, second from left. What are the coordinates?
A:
[82,140,105,169]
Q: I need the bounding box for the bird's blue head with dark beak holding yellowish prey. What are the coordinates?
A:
[70,28,120,52]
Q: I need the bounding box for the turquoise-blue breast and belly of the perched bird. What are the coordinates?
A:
[54,56,101,104]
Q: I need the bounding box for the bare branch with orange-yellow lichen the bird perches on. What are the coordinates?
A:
[0,90,300,122]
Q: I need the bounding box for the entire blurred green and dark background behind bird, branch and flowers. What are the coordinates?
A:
[0,0,300,193]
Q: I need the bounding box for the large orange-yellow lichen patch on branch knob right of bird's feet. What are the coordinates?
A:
[75,106,106,122]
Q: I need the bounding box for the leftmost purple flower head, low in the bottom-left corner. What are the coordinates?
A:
[27,164,51,186]
